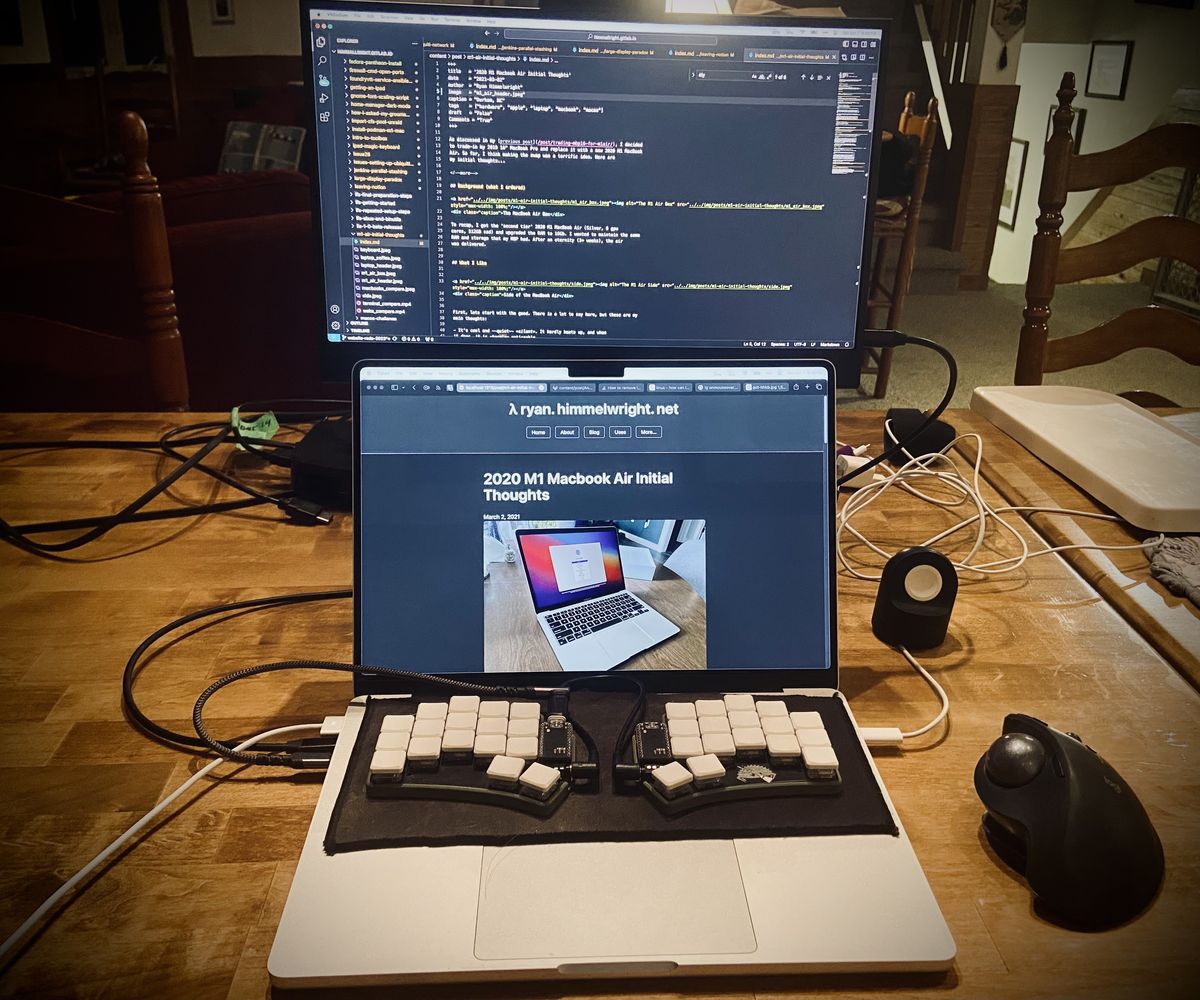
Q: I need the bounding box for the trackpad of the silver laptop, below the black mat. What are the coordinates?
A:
[475,840,757,959]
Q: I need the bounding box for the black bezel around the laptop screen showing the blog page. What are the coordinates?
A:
[350,357,838,695]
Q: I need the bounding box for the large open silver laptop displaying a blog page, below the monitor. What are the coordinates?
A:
[269,363,955,988]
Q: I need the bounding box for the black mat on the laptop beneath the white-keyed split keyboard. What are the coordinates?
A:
[325,690,899,854]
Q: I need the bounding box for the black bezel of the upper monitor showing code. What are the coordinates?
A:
[300,0,890,388]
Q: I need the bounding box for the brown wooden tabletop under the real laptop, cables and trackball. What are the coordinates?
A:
[0,413,1200,999]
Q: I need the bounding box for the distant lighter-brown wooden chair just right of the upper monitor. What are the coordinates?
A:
[863,90,937,400]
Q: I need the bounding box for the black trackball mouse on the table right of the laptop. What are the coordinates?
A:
[974,714,1163,928]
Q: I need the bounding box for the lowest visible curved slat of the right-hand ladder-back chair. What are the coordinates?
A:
[1040,306,1200,371]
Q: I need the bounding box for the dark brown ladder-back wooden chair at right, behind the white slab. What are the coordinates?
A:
[1014,73,1200,406]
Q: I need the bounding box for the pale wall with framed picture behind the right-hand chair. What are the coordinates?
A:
[989,0,1200,285]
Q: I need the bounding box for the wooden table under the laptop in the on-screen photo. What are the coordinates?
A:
[484,562,708,672]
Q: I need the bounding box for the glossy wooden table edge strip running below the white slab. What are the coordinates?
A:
[962,412,1200,687]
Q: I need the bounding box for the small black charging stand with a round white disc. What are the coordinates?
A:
[871,545,959,649]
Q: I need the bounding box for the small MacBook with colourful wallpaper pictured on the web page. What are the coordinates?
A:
[515,525,679,671]
